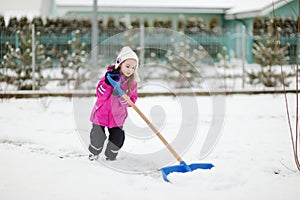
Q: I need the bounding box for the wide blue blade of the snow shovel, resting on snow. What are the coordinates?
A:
[160,161,214,182]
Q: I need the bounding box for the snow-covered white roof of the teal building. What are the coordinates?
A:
[56,0,292,19]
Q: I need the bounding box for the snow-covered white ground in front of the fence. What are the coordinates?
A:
[0,94,300,200]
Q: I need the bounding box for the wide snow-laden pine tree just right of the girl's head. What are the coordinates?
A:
[141,32,211,88]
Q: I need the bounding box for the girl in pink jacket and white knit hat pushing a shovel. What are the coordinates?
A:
[89,46,139,160]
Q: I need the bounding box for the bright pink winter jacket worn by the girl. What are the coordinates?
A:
[90,66,138,128]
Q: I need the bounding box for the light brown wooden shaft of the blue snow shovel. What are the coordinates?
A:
[122,93,183,162]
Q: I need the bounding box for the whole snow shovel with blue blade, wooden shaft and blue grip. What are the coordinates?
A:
[107,74,214,182]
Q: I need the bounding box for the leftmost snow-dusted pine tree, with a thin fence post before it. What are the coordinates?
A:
[3,28,51,90]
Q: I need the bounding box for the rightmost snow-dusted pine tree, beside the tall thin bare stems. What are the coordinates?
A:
[248,19,291,87]
